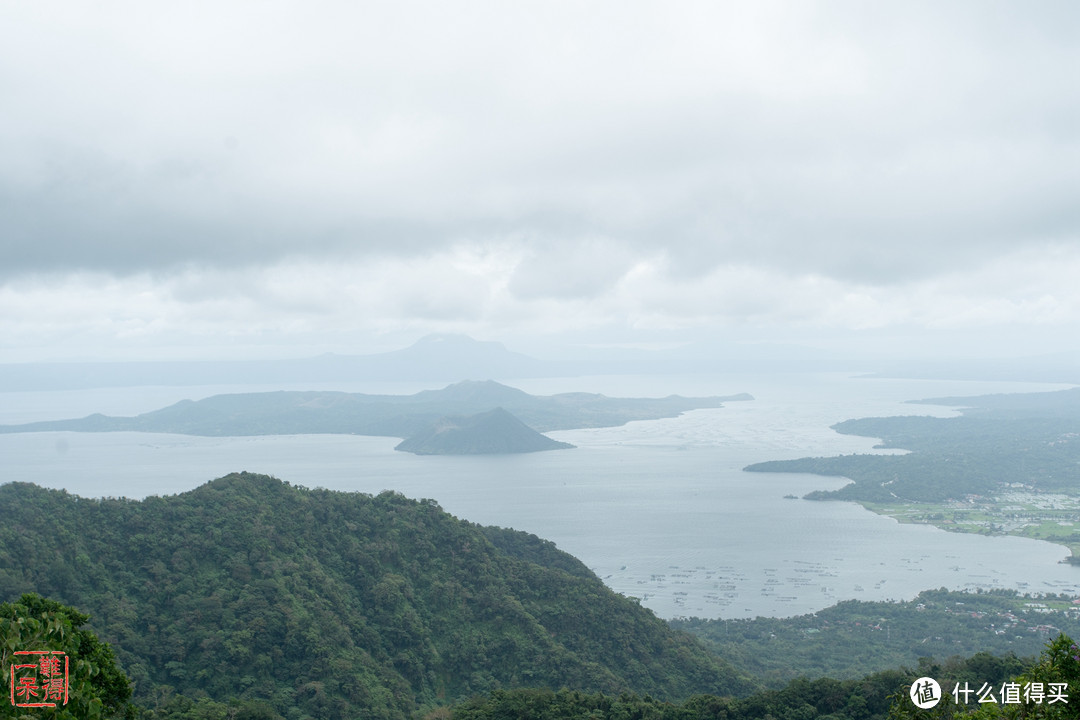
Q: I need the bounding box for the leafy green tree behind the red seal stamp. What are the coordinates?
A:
[0,594,137,720]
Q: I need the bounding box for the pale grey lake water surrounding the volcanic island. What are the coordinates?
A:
[0,375,1080,617]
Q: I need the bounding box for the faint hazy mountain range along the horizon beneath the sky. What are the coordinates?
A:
[0,334,1080,395]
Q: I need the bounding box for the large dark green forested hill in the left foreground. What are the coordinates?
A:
[0,473,748,720]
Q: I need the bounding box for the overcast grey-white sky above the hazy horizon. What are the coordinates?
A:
[0,0,1080,362]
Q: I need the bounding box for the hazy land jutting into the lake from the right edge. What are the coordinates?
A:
[744,388,1080,565]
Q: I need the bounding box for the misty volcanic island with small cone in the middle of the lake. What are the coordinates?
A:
[0,380,754,454]
